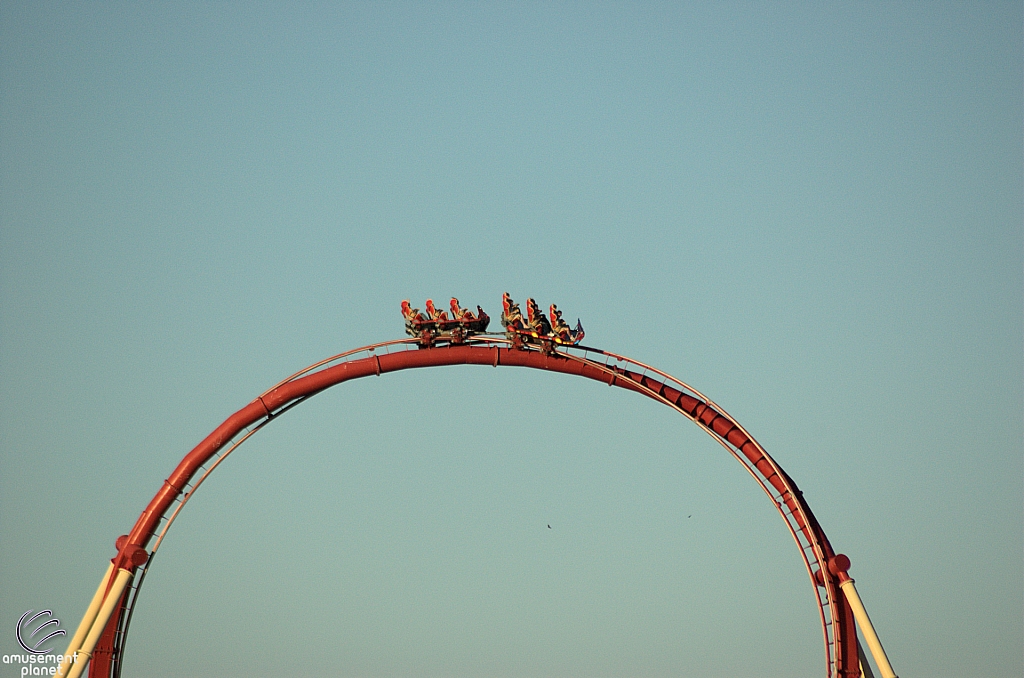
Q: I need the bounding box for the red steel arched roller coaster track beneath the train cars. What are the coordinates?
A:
[89,336,860,678]
